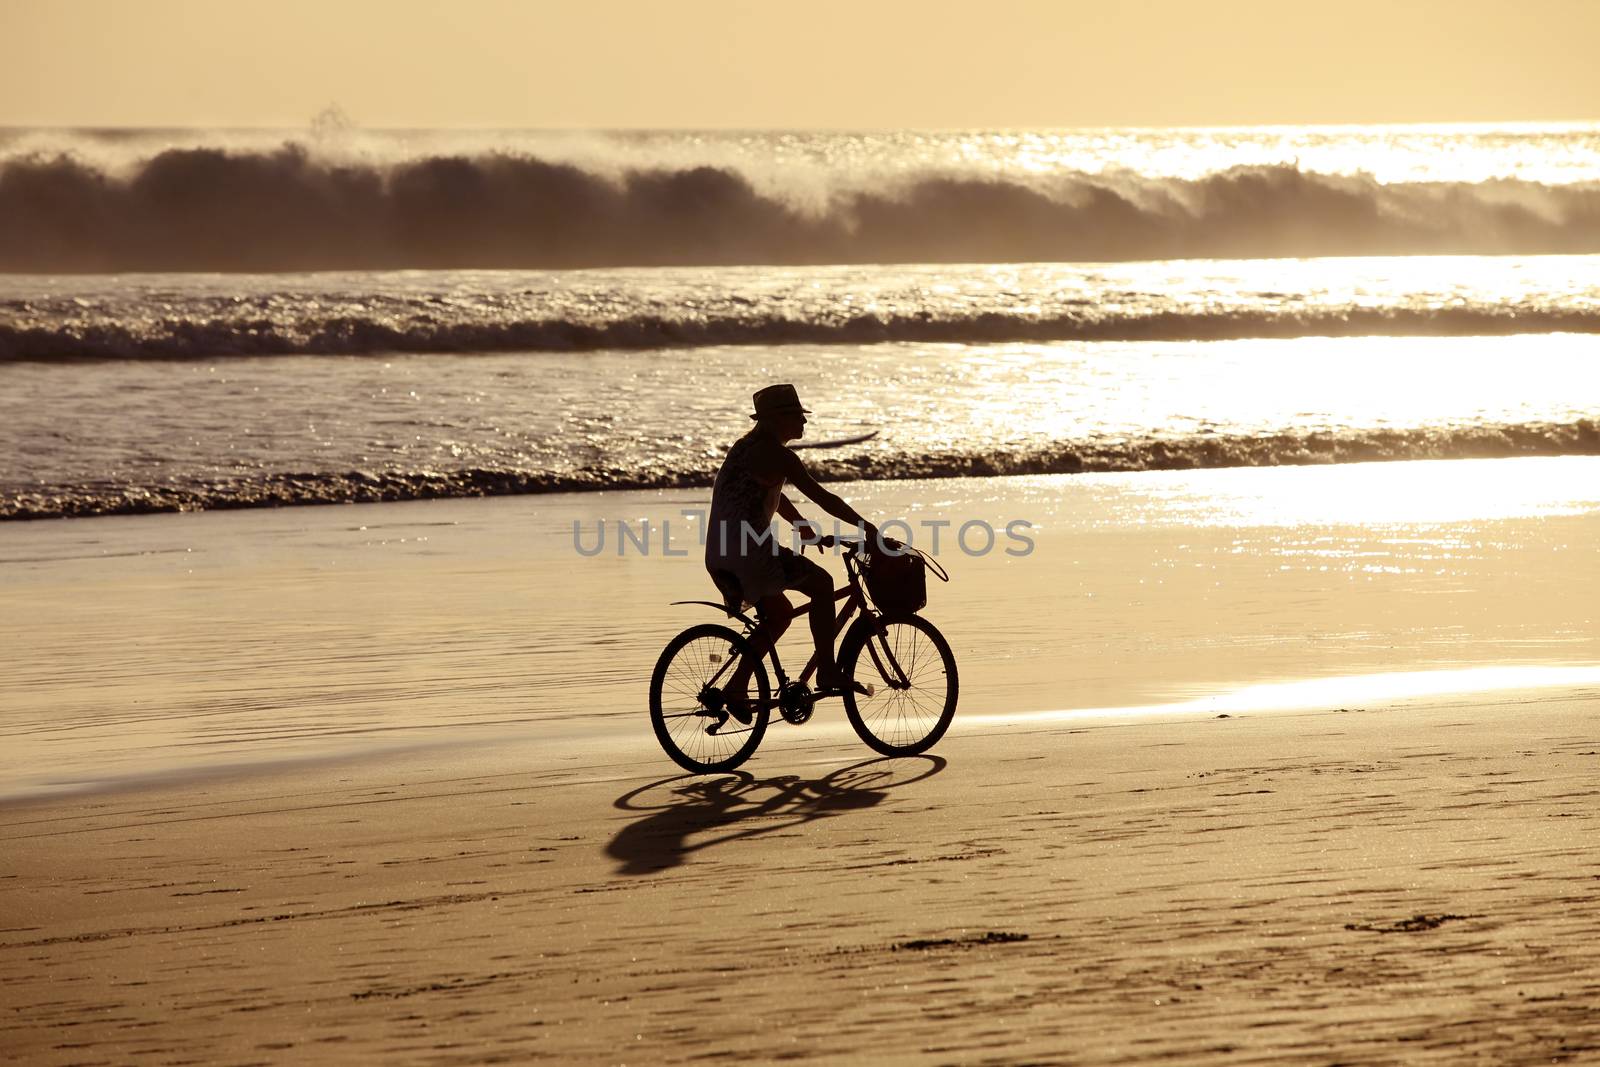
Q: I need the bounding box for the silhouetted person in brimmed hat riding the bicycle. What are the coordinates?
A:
[706,384,877,723]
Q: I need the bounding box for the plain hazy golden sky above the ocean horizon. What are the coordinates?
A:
[0,0,1600,128]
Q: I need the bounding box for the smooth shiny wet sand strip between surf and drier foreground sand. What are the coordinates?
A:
[0,458,1600,797]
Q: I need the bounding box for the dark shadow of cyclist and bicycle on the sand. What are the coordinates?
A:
[605,755,947,875]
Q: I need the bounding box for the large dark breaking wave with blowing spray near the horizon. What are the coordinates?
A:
[0,142,1600,274]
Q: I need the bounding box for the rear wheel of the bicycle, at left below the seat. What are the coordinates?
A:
[650,622,771,774]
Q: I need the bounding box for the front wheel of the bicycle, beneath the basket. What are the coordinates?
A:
[838,614,960,755]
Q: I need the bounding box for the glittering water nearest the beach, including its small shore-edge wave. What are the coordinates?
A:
[0,321,1600,520]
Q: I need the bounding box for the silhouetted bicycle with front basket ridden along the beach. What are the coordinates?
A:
[650,537,960,774]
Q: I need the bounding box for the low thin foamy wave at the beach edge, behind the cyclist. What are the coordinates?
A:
[0,419,1600,520]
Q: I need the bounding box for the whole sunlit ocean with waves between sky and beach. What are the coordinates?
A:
[0,125,1600,520]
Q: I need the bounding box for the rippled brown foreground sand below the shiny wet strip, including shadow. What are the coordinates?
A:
[0,689,1600,1064]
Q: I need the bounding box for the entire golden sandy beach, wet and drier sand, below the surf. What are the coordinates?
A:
[0,458,1600,1064]
